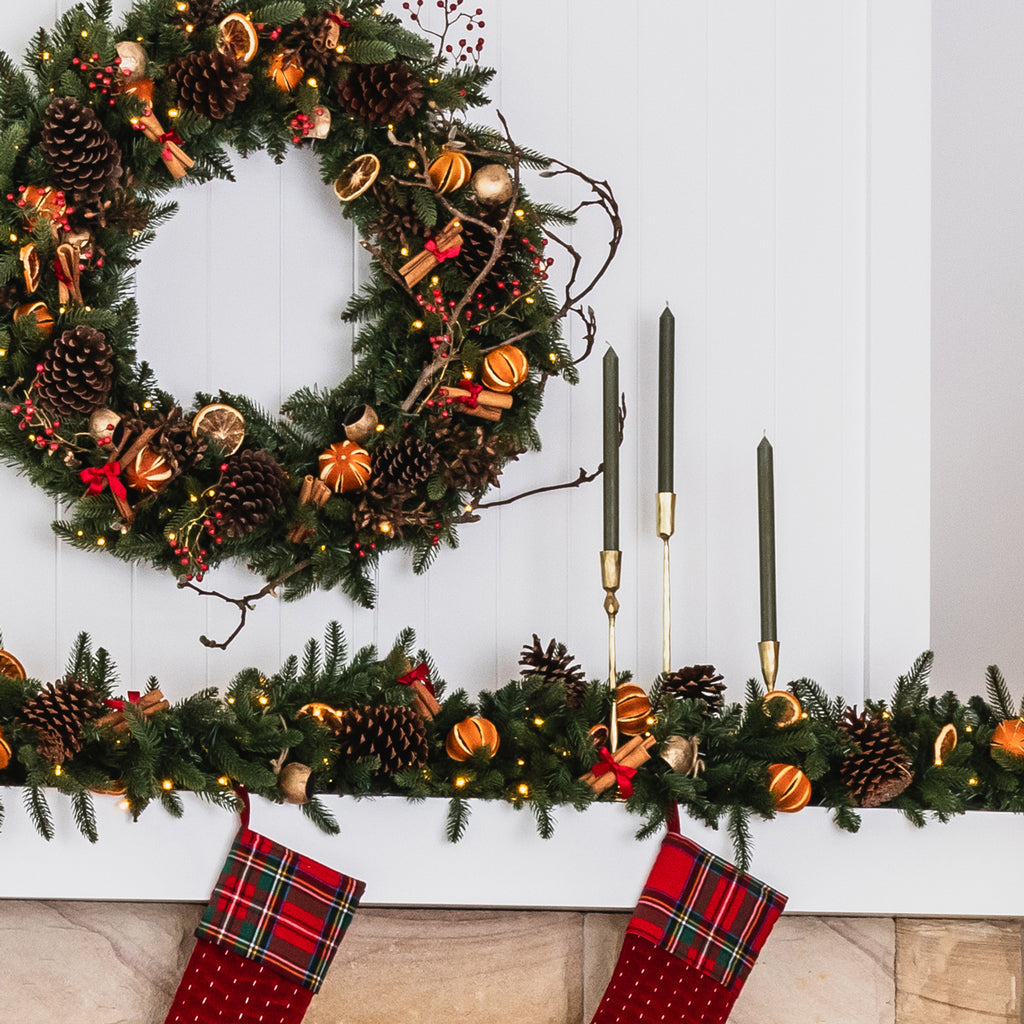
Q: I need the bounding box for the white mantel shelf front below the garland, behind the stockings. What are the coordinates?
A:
[0,788,1024,918]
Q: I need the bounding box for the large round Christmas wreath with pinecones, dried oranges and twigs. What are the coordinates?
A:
[0,0,620,626]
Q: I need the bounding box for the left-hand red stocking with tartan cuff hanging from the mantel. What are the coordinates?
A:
[164,805,364,1024]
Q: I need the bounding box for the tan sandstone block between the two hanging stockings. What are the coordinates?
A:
[305,909,583,1024]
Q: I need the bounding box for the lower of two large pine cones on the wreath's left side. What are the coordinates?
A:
[36,324,114,418]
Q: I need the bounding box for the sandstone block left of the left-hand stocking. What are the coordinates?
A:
[0,900,200,1024]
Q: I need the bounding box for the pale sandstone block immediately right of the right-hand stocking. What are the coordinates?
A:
[729,914,897,1024]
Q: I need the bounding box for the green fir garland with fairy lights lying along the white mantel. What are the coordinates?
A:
[0,624,1024,865]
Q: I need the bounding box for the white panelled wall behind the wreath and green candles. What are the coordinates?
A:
[0,0,931,897]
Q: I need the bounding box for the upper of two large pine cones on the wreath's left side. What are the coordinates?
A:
[39,96,121,200]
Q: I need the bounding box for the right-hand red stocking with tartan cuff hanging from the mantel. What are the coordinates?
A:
[591,808,786,1024]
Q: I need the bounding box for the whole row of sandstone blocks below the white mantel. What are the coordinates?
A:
[0,900,1024,1024]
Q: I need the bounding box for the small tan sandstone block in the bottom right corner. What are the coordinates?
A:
[896,918,1022,1024]
